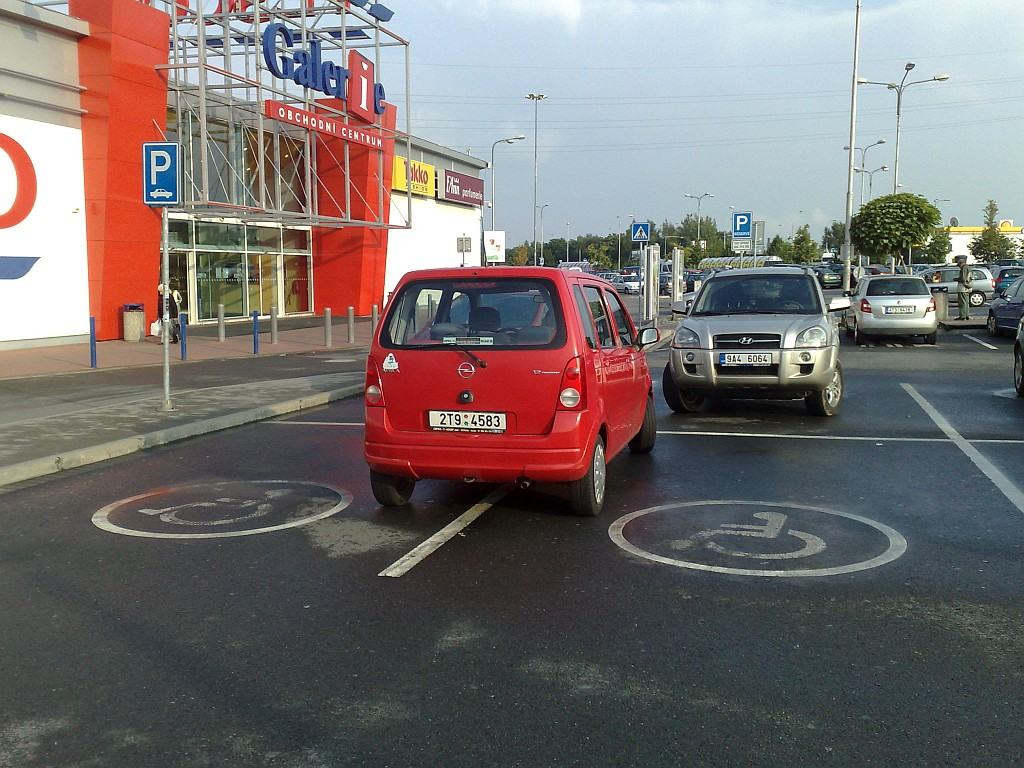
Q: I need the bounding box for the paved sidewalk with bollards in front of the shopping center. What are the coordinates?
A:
[0,318,370,486]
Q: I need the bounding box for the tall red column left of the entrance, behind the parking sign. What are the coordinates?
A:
[69,0,170,340]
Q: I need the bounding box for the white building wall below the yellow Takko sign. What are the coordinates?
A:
[384,193,480,297]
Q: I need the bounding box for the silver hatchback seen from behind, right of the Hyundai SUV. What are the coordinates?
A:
[846,274,938,344]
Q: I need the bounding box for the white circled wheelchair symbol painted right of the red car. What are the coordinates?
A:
[608,500,907,577]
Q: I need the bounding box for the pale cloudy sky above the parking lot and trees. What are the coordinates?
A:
[382,0,1024,243]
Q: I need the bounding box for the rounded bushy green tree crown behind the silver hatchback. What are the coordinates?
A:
[850,193,942,270]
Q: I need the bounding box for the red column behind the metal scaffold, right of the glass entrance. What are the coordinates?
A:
[312,104,397,315]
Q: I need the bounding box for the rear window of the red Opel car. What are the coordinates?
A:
[381,278,565,348]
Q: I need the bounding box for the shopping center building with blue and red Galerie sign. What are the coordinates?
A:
[0,0,486,348]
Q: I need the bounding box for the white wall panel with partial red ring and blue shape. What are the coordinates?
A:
[0,115,89,342]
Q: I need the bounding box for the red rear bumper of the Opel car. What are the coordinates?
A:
[364,408,598,482]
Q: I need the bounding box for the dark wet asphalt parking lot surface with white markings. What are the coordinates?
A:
[0,333,1024,766]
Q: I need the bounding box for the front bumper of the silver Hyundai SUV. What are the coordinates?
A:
[672,347,839,397]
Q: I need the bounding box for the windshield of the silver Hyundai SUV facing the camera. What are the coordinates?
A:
[691,272,822,315]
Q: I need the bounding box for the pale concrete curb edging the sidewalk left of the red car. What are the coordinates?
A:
[0,384,362,486]
